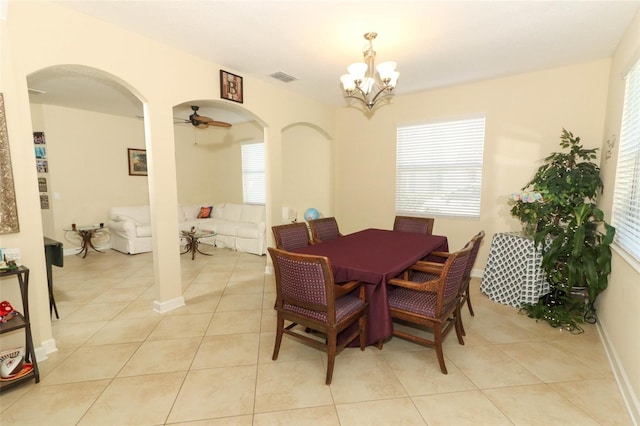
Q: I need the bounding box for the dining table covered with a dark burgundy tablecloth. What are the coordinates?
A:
[291,228,449,345]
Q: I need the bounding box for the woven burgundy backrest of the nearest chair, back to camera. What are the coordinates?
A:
[268,247,336,324]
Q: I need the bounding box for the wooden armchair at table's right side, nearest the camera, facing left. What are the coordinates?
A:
[378,242,473,374]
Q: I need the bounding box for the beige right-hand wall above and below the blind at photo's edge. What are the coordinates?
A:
[598,8,640,423]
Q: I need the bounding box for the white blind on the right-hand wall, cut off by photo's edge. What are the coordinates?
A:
[611,61,640,261]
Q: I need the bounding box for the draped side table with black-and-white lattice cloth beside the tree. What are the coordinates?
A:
[480,232,550,307]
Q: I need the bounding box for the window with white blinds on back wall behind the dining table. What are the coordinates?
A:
[396,115,485,217]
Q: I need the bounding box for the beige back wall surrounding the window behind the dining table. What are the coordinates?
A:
[336,60,610,269]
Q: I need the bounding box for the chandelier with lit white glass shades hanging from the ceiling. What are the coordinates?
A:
[340,33,400,111]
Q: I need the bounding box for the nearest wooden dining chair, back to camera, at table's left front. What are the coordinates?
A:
[269,247,367,385]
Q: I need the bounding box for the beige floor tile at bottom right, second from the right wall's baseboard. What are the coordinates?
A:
[483,384,597,426]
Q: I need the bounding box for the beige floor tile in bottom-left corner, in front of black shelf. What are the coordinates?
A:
[0,380,109,426]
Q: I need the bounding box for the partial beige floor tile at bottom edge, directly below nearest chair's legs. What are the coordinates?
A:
[253,405,344,426]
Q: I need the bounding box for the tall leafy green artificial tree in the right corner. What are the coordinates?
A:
[510,129,615,331]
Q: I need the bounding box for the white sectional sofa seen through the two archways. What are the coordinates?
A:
[107,203,267,255]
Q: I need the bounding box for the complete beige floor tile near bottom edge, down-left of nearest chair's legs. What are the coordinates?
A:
[168,366,256,423]
